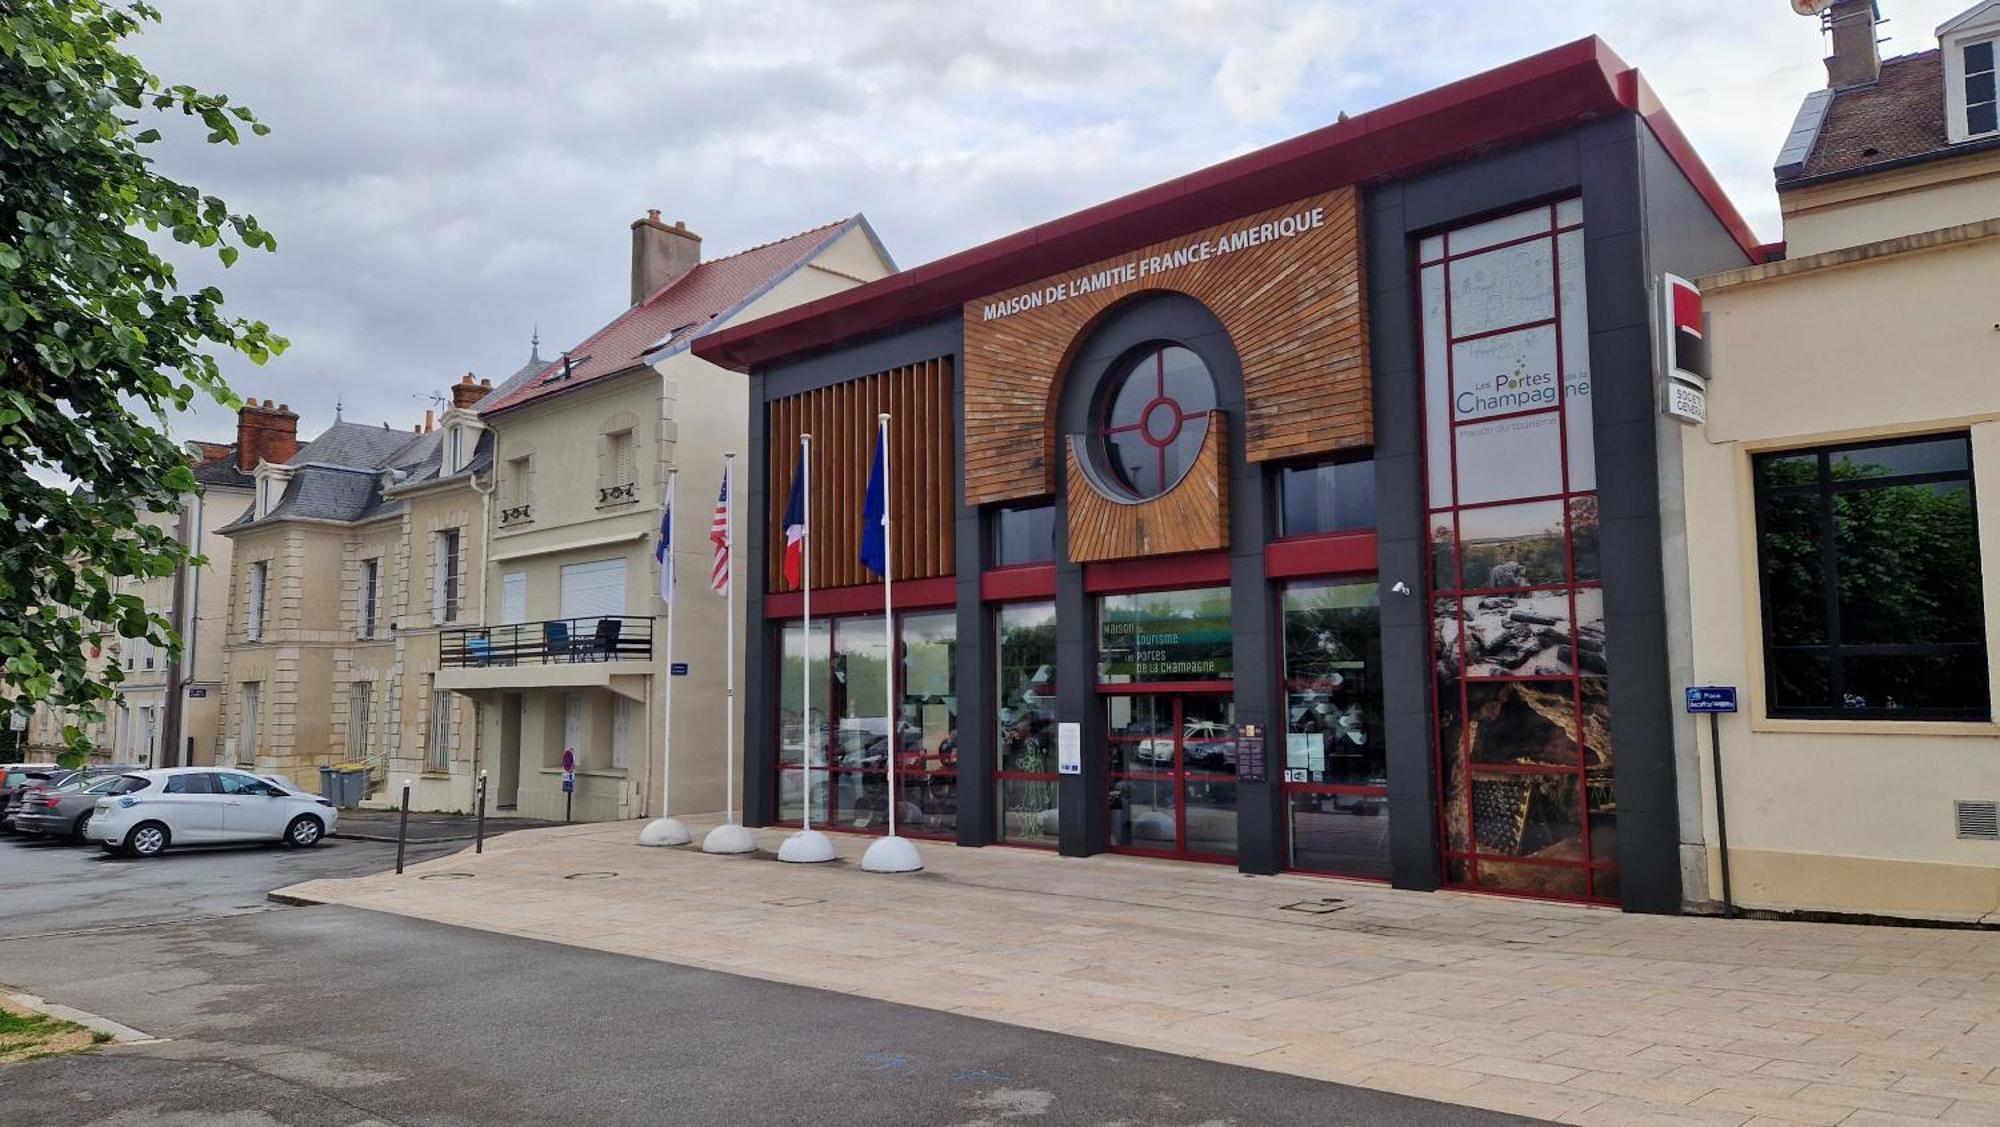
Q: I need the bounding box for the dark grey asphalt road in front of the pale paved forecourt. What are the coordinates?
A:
[0,841,1524,1127]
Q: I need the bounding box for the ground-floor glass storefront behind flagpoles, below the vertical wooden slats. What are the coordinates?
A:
[778,611,958,837]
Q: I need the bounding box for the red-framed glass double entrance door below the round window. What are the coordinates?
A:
[1104,693,1236,861]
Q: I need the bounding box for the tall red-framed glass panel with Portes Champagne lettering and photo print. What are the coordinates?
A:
[1418,200,1618,901]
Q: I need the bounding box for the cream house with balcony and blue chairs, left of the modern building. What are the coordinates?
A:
[454,212,894,819]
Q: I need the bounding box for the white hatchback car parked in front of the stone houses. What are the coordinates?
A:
[86,767,340,857]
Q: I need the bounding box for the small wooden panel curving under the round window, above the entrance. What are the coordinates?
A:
[1064,412,1230,564]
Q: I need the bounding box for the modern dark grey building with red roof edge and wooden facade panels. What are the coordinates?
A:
[694,38,1758,911]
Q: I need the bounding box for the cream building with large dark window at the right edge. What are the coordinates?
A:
[1676,0,2000,921]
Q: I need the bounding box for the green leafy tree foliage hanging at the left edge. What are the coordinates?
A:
[0,0,286,755]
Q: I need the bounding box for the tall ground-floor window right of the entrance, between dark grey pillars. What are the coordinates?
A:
[1278,577,1390,879]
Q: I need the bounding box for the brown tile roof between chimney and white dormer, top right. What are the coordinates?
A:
[1798,50,1950,180]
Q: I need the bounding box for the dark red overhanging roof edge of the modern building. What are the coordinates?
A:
[694,36,1762,372]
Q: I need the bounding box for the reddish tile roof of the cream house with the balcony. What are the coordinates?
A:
[480,216,860,416]
